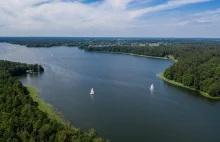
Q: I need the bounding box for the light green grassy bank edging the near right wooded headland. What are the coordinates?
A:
[157,73,220,100]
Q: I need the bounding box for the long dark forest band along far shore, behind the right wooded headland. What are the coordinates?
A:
[82,41,220,59]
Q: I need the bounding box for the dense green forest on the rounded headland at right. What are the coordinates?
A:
[164,52,220,96]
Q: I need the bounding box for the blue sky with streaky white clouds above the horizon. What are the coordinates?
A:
[0,0,220,38]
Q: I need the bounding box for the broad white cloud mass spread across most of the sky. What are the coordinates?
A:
[0,0,220,36]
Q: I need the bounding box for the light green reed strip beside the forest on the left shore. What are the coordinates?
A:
[27,86,65,124]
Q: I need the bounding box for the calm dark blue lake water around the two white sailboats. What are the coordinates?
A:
[0,43,220,142]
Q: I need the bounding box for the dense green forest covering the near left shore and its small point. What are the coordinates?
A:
[0,60,104,142]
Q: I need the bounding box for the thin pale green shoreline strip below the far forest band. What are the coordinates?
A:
[95,51,178,62]
